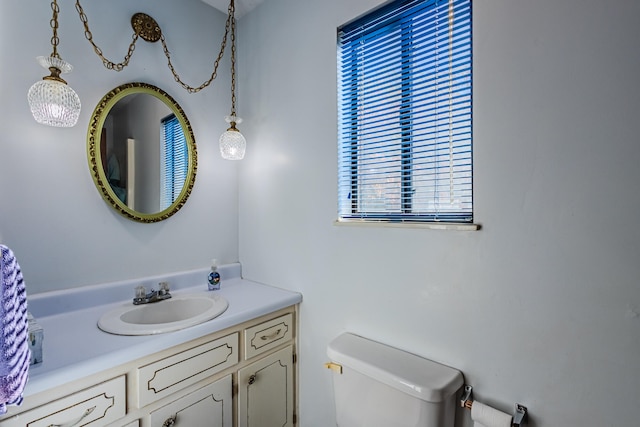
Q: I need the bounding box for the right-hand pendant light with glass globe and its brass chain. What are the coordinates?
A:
[220,0,247,160]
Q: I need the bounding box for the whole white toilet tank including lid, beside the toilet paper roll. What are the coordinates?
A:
[327,333,463,427]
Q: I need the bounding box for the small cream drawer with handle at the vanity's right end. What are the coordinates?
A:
[244,313,293,359]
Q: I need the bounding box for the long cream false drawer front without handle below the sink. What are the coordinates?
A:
[137,333,238,408]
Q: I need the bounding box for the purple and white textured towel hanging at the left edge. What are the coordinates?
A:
[0,245,31,415]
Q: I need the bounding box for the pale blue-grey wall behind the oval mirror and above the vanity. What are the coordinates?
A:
[0,0,238,294]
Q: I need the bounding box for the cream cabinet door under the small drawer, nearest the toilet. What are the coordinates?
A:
[238,346,294,427]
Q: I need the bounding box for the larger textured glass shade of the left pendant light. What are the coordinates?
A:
[27,56,81,127]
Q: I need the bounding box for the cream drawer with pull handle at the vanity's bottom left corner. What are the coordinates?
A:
[1,376,126,427]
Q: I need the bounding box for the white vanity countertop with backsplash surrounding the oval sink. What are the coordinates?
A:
[24,264,302,397]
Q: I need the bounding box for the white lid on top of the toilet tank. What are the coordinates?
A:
[327,333,463,403]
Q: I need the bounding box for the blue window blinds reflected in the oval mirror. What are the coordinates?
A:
[160,114,189,210]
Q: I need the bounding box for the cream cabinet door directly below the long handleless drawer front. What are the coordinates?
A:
[150,375,233,427]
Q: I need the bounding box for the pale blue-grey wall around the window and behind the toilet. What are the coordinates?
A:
[239,0,640,427]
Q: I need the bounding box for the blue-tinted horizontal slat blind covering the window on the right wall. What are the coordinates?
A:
[338,0,473,222]
